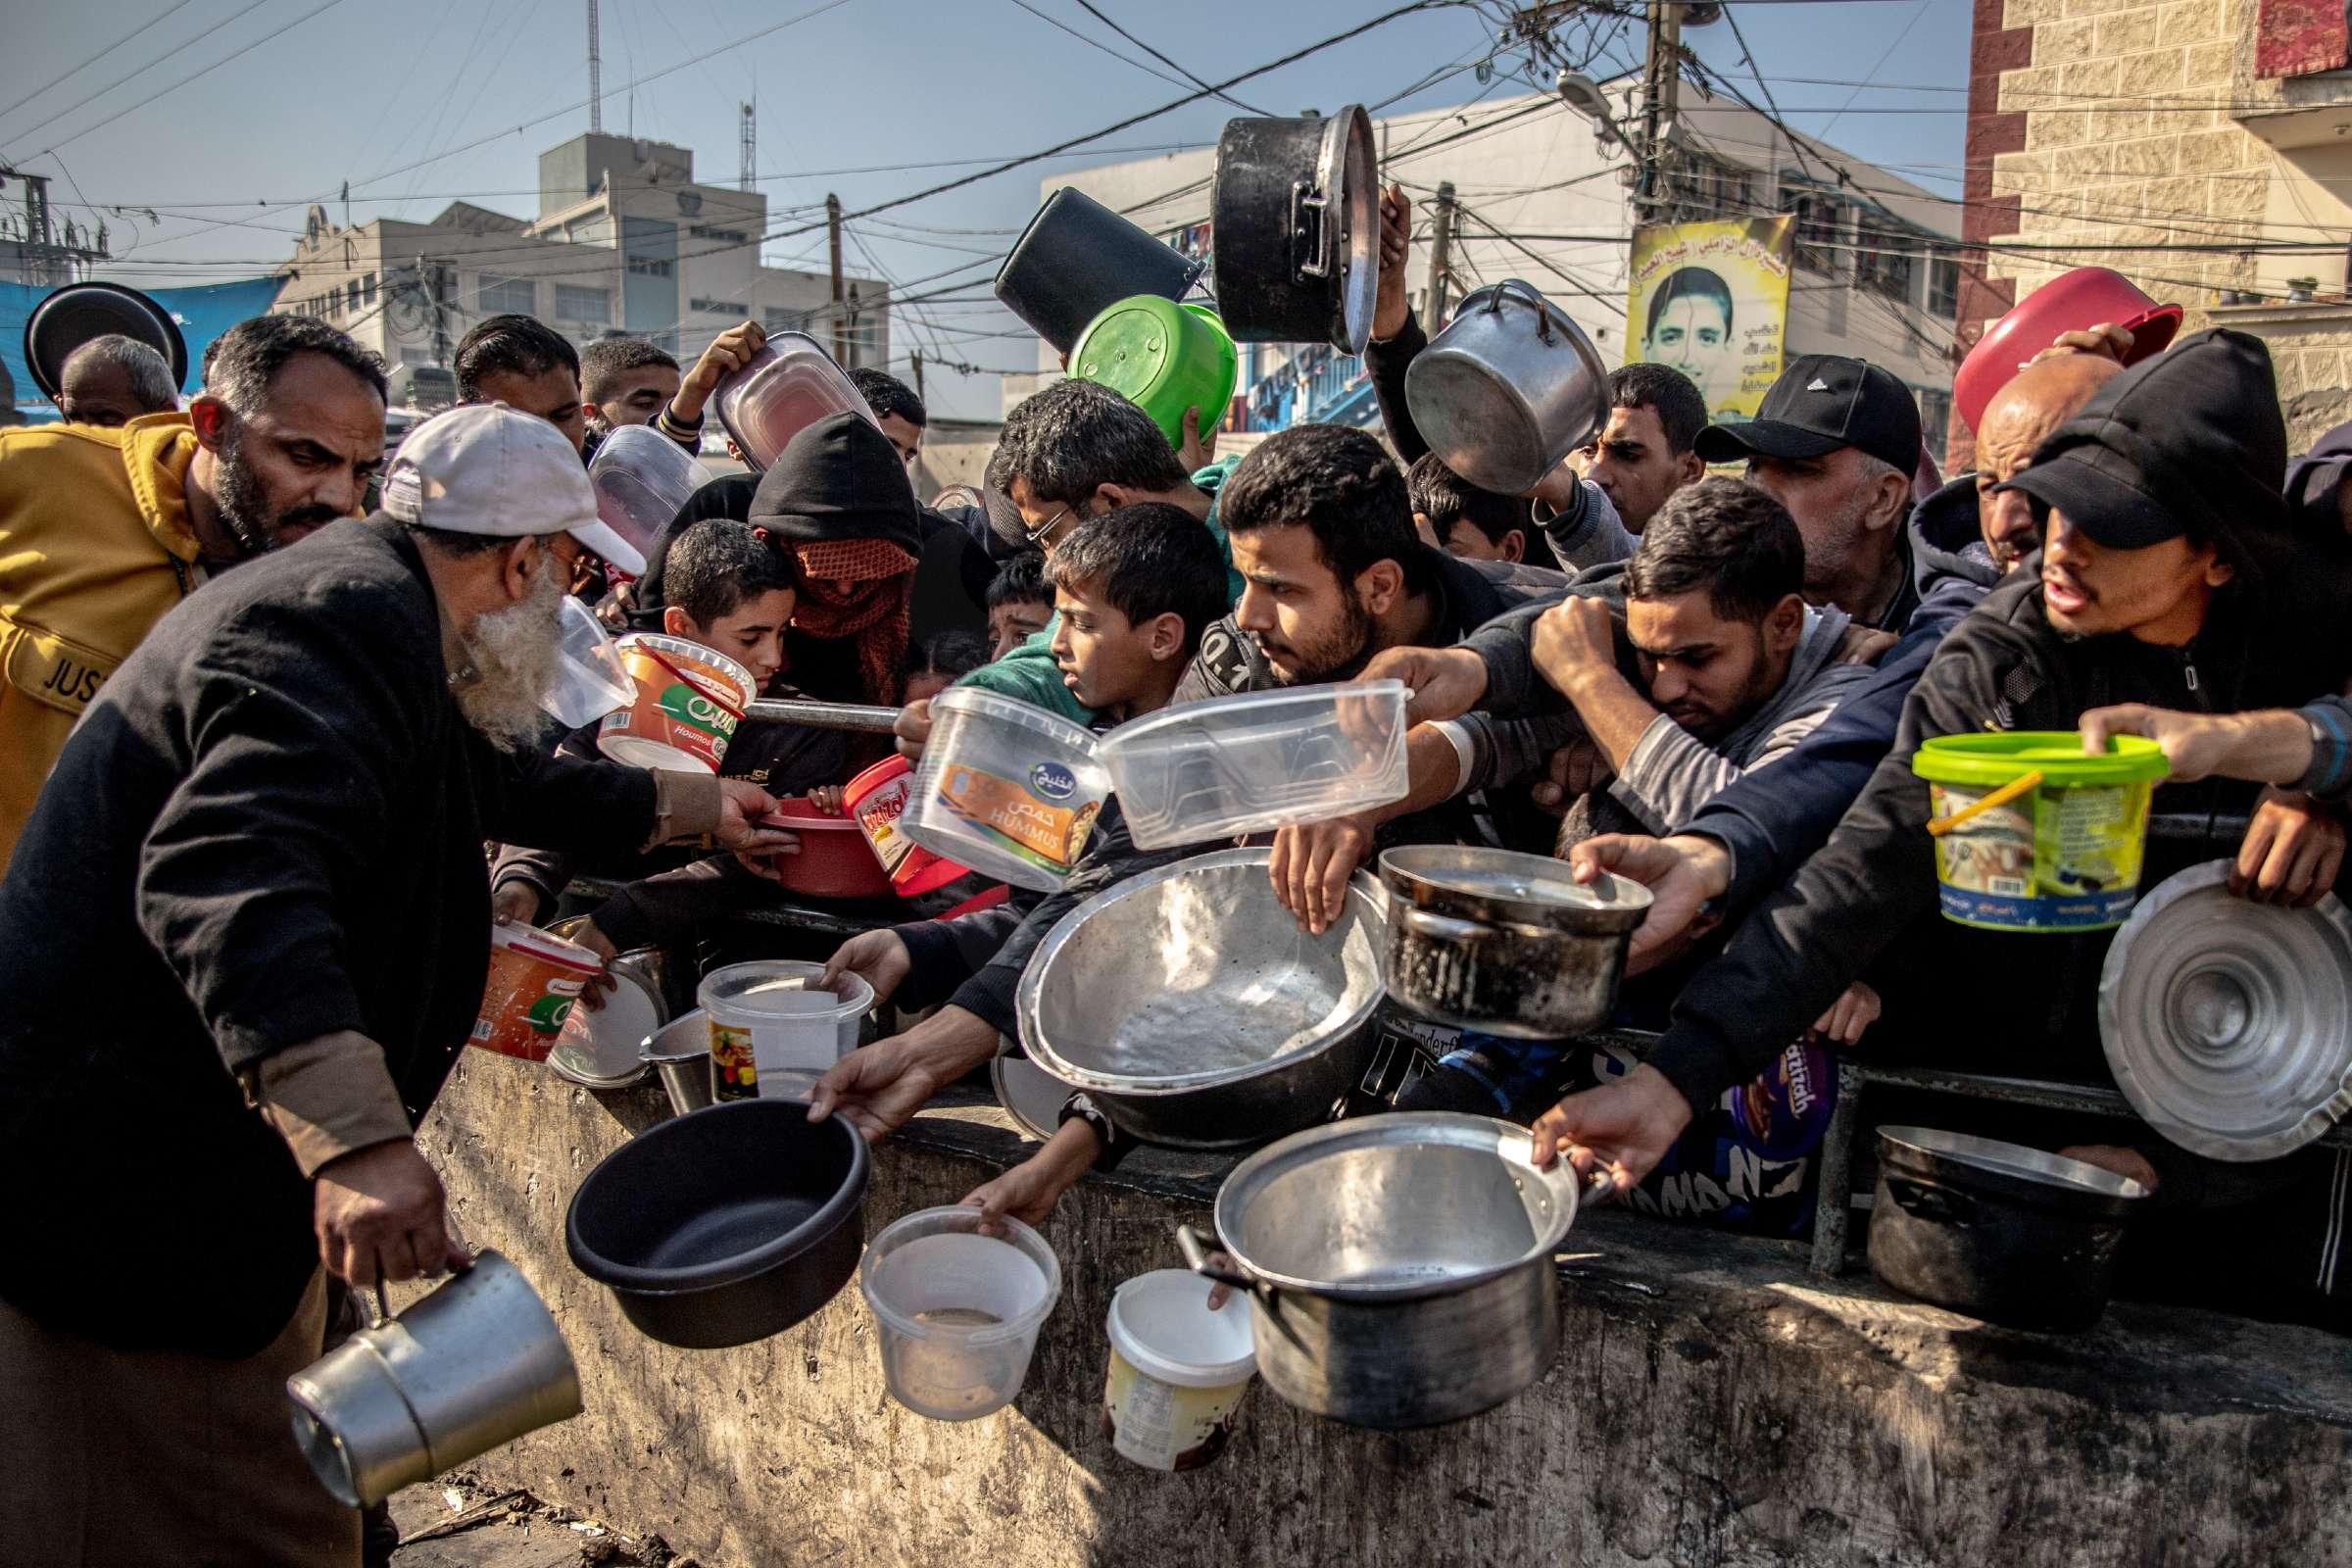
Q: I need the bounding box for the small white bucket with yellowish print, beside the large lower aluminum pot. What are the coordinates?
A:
[1103,1269,1258,1469]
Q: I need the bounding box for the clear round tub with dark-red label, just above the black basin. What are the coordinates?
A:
[694,959,875,1101]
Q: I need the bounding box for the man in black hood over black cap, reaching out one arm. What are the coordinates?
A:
[1536,329,2352,1325]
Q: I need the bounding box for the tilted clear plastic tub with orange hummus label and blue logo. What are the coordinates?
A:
[899,686,1114,894]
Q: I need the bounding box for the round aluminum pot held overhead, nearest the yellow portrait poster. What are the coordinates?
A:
[1401,277,1609,496]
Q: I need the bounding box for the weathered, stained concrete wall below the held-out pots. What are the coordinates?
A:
[425,1051,2352,1568]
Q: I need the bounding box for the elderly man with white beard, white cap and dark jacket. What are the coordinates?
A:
[0,405,790,1563]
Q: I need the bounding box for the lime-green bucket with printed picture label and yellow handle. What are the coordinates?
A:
[1912,731,2171,931]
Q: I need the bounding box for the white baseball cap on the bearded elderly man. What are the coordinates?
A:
[383,402,645,576]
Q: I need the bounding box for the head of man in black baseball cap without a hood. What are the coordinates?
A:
[1698,355,1919,632]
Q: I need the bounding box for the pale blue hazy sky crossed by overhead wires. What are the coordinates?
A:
[0,0,1971,414]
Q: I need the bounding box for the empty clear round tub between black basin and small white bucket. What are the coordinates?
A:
[858,1206,1060,1420]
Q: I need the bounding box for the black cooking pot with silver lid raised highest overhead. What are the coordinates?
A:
[1209,104,1381,355]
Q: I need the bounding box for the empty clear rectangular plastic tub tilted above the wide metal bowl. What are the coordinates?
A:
[1096,679,1409,849]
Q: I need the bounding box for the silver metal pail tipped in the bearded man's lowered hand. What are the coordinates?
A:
[287,1250,581,1507]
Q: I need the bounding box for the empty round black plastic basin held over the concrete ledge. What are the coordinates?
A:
[564,1101,868,1349]
